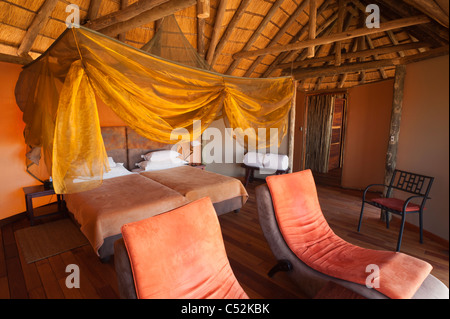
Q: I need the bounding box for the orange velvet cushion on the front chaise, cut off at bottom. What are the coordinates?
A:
[122,198,248,299]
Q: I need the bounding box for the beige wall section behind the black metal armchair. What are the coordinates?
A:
[397,56,449,240]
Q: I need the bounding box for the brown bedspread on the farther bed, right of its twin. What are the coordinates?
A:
[140,166,248,205]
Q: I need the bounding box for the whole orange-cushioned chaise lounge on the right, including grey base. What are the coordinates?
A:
[256,170,449,299]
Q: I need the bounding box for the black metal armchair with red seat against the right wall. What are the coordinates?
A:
[358,169,434,251]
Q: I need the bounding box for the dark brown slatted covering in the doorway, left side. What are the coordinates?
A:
[305,95,334,173]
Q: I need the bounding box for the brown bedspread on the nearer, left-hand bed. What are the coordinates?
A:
[65,174,189,254]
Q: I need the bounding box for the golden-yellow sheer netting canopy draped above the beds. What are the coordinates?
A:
[16,27,294,194]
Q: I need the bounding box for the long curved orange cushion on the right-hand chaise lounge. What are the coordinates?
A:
[266,170,432,299]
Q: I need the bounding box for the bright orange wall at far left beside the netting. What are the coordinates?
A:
[0,62,52,220]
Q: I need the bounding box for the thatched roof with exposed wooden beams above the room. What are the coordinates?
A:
[0,0,449,90]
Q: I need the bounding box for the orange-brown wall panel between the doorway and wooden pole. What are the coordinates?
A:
[342,80,394,189]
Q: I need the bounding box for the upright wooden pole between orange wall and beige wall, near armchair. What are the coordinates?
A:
[380,64,406,221]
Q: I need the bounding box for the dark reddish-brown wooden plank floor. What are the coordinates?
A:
[0,181,449,299]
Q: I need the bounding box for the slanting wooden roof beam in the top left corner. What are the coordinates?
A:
[17,0,58,56]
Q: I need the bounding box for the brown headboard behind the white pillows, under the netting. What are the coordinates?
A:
[101,126,173,170]
